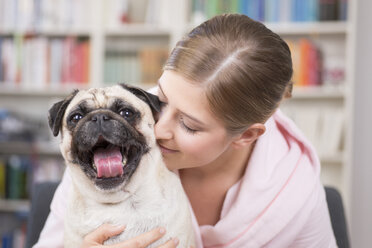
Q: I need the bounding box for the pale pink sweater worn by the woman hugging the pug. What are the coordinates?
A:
[34,110,337,248]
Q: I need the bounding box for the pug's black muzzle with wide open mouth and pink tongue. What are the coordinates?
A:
[67,109,148,189]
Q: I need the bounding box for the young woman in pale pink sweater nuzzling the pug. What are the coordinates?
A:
[35,14,337,248]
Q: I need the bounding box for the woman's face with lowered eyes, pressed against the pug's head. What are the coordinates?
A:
[155,71,237,170]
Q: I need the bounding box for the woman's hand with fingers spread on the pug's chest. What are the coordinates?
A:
[80,224,179,248]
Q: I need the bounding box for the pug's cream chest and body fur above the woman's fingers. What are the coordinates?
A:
[65,153,194,247]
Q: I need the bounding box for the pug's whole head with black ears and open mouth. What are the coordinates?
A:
[49,85,160,190]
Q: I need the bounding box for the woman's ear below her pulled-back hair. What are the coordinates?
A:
[232,123,266,149]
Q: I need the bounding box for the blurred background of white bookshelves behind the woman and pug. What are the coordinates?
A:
[0,0,372,248]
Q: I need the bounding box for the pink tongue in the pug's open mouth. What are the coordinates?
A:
[94,146,123,177]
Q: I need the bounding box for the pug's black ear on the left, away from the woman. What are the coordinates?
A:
[48,90,79,136]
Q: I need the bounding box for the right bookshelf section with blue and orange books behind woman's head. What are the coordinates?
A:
[185,0,353,198]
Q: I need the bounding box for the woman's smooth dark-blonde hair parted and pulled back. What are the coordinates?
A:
[164,14,293,133]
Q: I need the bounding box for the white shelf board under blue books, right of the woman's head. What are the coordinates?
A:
[265,21,348,35]
